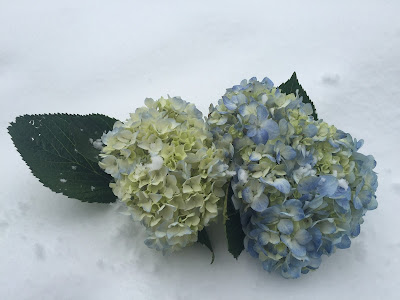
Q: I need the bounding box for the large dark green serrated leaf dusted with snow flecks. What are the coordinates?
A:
[8,114,116,203]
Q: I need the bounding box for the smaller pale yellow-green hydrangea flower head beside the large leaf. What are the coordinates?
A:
[99,97,232,253]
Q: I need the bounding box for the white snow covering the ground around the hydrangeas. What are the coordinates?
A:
[0,0,400,300]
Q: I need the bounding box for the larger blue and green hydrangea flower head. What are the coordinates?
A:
[208,78,377,278]
